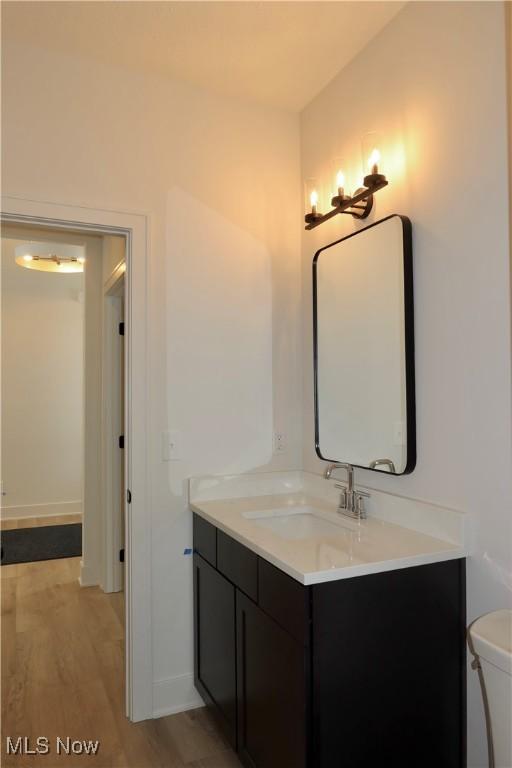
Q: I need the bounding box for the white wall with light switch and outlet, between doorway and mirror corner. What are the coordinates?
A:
[3,31,301,713]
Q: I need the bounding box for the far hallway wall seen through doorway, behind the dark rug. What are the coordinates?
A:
[2,236,84,517]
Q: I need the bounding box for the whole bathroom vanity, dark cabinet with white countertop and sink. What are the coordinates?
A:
[191,473,466,768]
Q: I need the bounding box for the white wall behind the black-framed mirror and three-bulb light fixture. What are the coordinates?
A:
[301,2,512,766]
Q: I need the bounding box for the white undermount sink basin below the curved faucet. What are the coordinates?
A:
[243,506,351,540]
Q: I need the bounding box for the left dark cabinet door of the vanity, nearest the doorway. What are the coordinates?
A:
[194,554,236,746]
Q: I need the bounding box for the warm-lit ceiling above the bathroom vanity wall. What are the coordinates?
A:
[2,0,405,111]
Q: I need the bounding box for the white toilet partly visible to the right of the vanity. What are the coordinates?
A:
[468,610,512,768]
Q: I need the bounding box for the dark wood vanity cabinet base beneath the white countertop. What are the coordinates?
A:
[194,515,466,768]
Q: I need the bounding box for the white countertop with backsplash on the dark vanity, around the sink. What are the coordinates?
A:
[189,472,467,584]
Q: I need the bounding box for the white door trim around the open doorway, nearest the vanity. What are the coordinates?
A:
[0,196,153,722]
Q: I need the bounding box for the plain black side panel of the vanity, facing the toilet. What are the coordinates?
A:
[313,560,466,768]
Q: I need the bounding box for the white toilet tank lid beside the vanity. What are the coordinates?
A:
[469,609,512,675]
